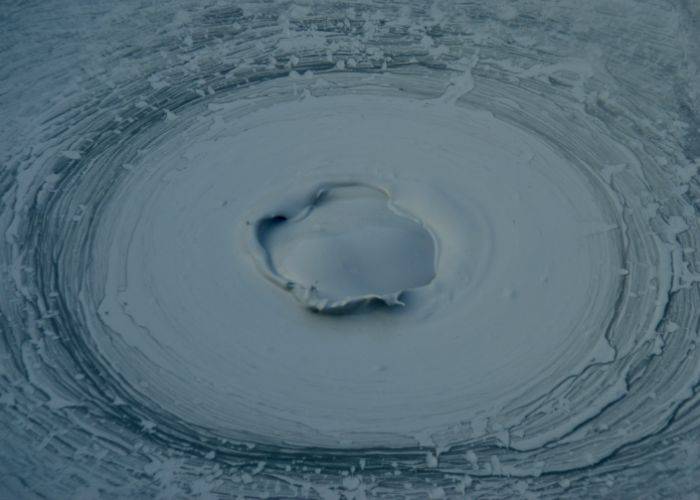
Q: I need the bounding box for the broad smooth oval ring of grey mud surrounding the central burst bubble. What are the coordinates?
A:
[90,95,625,447]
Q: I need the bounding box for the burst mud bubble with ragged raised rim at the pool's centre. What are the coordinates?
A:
[254,183,436,312]
